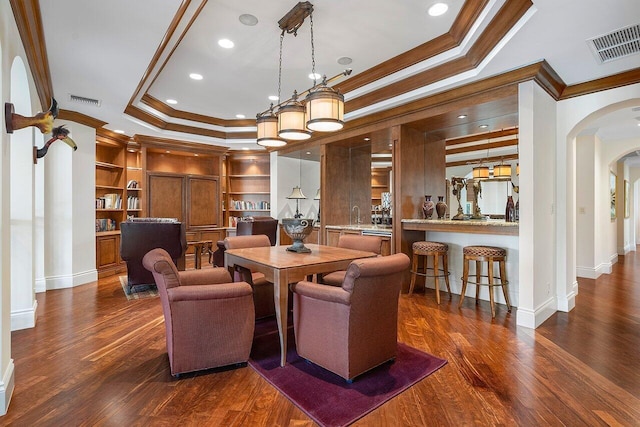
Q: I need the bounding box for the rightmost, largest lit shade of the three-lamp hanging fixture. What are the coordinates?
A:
[306,81,344,132]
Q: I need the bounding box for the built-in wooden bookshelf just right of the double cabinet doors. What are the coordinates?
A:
[224,152,271,227]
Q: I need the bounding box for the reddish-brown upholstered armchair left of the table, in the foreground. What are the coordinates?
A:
[142,249,255,376]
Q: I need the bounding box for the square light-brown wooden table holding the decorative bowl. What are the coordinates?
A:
[224,244,377,366]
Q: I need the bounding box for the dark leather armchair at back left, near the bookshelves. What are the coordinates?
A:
[120,218,187,290]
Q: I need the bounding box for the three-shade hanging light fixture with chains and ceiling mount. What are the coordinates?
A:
[256,1,351,147]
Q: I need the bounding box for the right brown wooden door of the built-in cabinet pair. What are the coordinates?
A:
[186,176,221,229]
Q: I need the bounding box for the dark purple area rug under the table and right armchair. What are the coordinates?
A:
[249,319,447,426]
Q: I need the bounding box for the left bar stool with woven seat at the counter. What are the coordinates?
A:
[409,242,451,304]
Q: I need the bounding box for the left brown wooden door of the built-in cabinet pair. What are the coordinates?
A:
[147,174,184,221]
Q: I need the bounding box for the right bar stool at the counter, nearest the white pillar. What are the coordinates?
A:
[458,246,511,317]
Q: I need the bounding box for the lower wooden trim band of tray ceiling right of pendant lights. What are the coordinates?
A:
[344,0,533,113]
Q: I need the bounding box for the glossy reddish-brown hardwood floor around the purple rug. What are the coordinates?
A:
[0,252,640,426]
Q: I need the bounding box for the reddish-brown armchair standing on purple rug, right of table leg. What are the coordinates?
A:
[292,253,409,382]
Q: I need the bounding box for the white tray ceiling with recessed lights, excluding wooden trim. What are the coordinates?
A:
[40,0,640,148]
